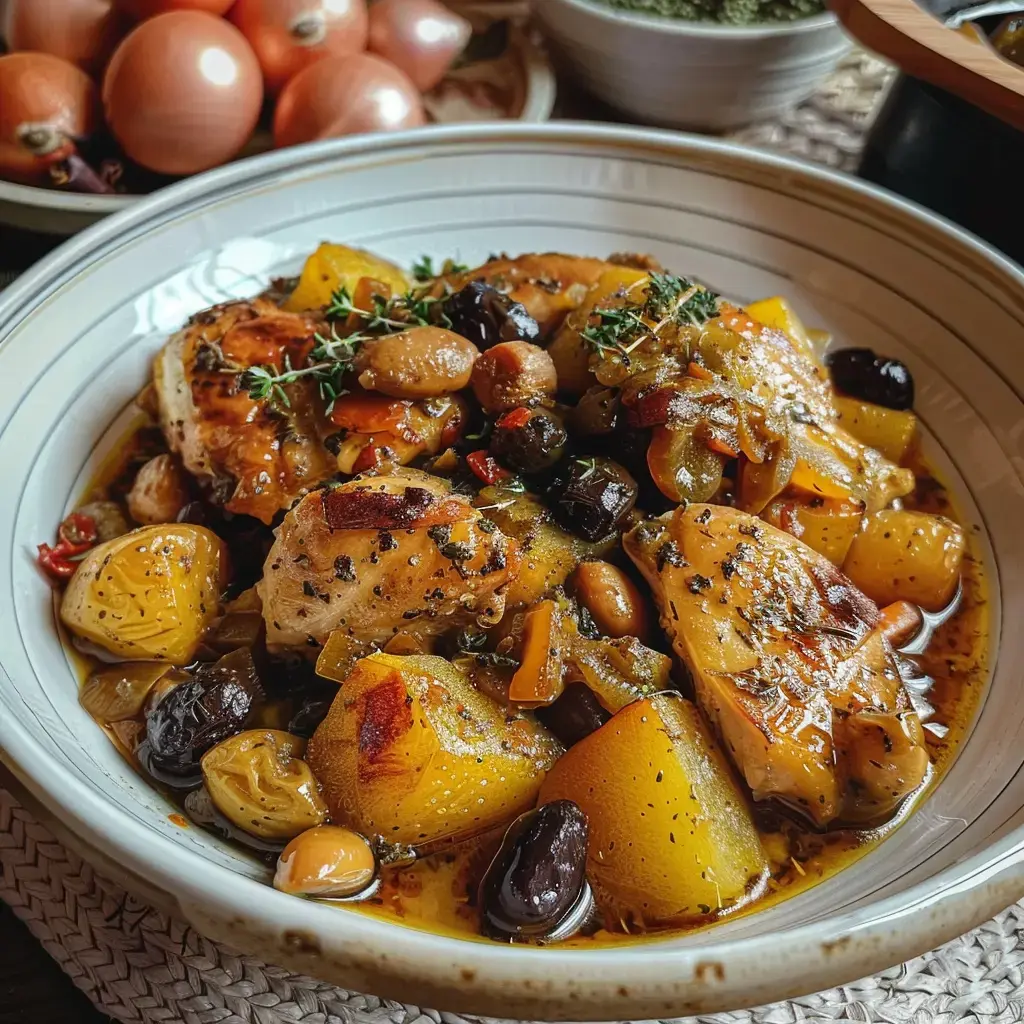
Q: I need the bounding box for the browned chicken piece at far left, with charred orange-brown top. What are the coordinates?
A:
[153,299,337,523]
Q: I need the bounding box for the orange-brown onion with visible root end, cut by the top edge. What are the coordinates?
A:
[230,0,369,93]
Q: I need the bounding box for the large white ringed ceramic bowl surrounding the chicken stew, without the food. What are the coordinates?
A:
[0,124,1024,1020]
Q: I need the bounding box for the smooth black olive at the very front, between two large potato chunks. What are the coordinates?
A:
[479,800,589,941]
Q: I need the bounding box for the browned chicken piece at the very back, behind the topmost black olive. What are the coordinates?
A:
[437,253,609,337]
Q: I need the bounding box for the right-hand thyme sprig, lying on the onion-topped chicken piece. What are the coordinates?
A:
[581,273,719,366]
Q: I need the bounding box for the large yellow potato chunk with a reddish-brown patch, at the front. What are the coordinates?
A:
[306,654,561,849]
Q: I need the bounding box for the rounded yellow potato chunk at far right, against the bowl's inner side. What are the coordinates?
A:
[843,509,967,611]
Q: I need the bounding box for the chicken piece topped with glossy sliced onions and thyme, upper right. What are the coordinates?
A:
[590,293,913,513]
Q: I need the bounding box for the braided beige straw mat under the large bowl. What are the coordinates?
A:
[0,52,1024,1024]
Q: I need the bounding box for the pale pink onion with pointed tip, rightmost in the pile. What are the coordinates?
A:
[370,0,473,92]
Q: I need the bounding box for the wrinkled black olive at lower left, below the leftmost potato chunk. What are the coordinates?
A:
[138,648,262,790]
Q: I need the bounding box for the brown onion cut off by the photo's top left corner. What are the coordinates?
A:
[5,0,127,74]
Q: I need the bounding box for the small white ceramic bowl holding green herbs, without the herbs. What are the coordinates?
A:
[534,0,850,131]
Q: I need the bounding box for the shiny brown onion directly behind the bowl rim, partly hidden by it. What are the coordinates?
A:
[273,53,426,147]
